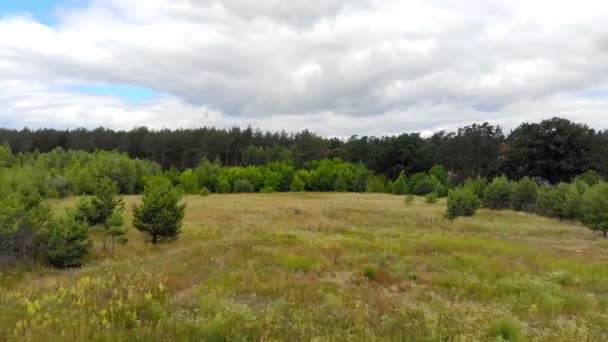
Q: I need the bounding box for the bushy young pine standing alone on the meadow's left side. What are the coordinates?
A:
[133,176,186,244]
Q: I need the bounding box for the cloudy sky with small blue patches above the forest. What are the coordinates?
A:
[0,0,608,137]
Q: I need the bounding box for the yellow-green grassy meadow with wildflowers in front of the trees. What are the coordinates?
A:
[0,193,608,341]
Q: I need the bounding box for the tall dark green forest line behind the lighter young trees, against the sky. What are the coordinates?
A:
[0,117,608,184]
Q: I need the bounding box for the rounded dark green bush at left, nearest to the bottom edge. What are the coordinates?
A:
[42,215,92,268]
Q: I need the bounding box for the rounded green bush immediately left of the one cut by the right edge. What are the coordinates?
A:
[538,183,582,220]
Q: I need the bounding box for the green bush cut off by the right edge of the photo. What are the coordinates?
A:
[582,183,608,238]
